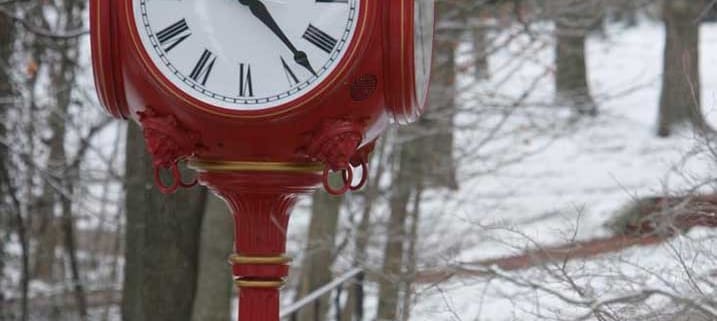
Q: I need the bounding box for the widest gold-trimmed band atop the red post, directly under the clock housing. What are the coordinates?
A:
[189,159,324,173]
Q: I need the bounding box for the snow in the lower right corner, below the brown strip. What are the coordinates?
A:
[411,230,717,321]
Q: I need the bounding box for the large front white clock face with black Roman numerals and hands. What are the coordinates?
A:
[132,0,360,111]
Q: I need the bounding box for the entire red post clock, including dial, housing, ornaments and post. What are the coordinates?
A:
[90,0,434,321]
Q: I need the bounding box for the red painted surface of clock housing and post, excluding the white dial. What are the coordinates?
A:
[90,0,430,321]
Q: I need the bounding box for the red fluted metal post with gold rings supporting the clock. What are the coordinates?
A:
[194,169,321,321]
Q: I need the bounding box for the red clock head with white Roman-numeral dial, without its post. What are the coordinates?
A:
[89,0,434,165]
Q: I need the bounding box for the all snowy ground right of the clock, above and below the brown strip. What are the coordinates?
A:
[402,22,717,320]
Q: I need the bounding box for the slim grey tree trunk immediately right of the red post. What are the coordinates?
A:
[296,186,342,321]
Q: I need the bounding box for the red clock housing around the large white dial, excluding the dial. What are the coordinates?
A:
[91,0,430,169]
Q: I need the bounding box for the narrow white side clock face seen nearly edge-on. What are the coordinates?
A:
[414,0,435,106]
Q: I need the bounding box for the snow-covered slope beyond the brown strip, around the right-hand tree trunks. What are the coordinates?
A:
[422,23,717,260]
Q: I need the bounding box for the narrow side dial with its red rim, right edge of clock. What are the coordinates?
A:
[384,0,435,123]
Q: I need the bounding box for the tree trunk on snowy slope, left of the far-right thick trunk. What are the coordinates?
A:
[555,9,598,116]
